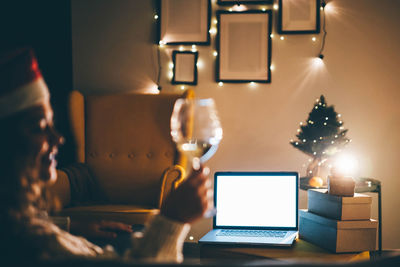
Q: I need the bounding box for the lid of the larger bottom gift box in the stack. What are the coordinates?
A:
[300,210,378,229]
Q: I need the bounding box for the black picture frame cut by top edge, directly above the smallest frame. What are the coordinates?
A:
[158,0,211,45]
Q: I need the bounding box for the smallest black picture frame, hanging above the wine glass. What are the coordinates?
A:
[171,50,199,85]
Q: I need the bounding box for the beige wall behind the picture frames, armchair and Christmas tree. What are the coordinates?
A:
[72,0,400,248]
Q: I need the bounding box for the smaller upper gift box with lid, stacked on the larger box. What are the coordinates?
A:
[308,189,372,220]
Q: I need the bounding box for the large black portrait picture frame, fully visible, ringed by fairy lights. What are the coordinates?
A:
[216,10,272,83]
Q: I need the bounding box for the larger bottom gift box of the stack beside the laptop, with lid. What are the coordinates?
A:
[299,210,378,253]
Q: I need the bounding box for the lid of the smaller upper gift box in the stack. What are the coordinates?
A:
[308,189,372,205]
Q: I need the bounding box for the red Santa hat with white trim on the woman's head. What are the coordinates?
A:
[0,48,50,118]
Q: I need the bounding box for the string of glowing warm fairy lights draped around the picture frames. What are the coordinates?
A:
[153,0,327,91]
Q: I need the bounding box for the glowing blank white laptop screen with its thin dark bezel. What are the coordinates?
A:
[214,172,298,230]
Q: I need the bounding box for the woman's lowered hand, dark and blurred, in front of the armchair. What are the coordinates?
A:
[71,220,132,239]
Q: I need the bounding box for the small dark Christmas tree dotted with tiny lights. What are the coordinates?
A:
[290,95,350,176]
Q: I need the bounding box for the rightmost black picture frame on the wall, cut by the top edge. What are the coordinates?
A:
[278,0,321,34]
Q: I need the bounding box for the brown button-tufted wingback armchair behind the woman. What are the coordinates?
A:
[50,91,192,224]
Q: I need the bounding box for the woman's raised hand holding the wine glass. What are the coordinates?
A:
[160,166,212,223]
